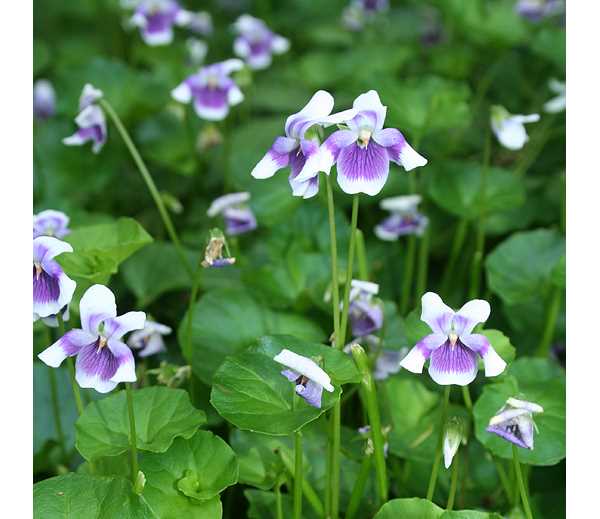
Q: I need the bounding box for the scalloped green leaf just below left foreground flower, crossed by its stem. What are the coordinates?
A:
[76,387,206,460]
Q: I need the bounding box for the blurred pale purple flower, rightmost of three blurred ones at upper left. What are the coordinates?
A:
[233,14,290,70]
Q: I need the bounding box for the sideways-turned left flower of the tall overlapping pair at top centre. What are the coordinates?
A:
[251,90,348,198]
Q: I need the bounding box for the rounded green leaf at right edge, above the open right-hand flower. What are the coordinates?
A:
[485,229,565,305]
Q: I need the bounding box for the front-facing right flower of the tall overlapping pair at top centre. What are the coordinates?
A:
[308,90,427,196]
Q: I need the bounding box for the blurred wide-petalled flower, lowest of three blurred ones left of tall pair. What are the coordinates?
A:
[171,59,244,121]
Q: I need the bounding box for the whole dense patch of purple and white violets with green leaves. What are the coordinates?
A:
[33,0,565,519]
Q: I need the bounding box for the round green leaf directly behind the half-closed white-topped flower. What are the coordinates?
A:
[210,336,359,436]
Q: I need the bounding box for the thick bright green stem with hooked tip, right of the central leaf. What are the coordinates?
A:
[352,344,388,504]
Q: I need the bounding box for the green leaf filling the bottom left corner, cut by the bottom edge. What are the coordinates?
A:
[33,473,157,519]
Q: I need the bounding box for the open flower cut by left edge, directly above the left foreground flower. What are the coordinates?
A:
[33,236,76,320]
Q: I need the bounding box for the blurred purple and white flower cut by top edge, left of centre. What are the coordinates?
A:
[130,0,192,46]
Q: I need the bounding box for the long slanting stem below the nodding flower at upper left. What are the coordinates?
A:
[99,99,194,277]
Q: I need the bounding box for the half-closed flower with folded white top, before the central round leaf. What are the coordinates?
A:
[273,349,333,409]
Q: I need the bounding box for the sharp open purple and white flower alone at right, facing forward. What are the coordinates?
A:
[400,292,506,386]
